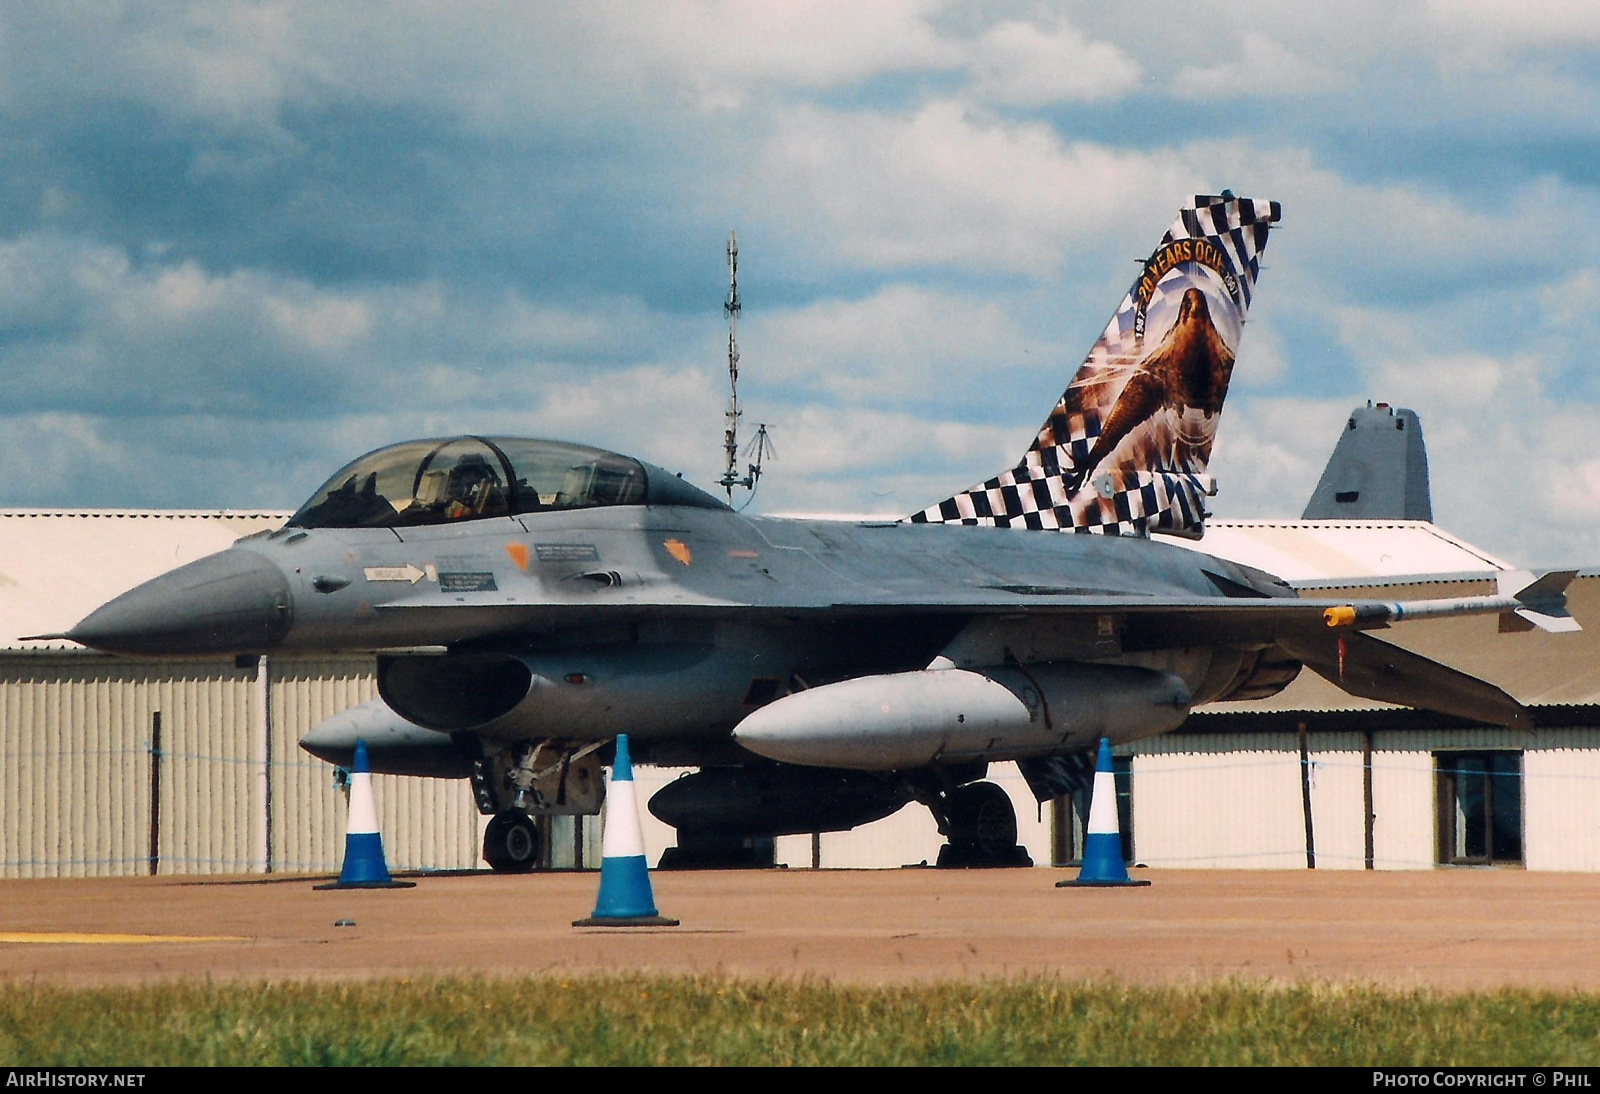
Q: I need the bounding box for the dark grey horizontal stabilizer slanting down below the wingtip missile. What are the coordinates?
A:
[1278,632,1533,731]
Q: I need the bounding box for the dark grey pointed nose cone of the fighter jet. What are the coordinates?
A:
[67,550,293,656]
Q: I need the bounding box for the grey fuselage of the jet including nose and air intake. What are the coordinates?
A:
[75,505,1291,758]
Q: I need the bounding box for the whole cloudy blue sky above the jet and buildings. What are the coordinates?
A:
[0,8,1600,565]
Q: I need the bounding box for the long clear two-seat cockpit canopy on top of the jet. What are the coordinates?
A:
[290,437,726,528]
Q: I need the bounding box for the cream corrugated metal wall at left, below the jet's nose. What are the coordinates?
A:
[0,654,480,876]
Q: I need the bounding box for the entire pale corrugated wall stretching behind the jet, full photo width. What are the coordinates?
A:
[9,654,1600,876]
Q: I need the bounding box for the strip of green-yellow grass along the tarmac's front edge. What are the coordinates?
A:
[0,977,1600,1067]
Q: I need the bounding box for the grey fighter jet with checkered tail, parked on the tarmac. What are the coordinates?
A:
[67,192,1578,870]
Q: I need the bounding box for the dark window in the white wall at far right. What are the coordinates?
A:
[1434,752,1522,865]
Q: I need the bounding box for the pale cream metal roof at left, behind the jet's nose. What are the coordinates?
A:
[0,509,290,649]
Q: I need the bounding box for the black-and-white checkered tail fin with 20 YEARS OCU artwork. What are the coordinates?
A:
[909,190,1282,537]
